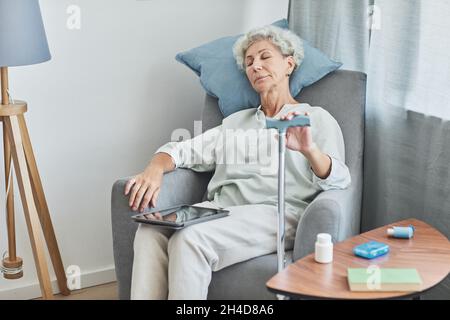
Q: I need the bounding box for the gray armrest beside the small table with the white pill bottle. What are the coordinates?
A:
[293,189,354,261]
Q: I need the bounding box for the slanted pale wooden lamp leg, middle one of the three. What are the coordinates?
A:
[4,116,53,299]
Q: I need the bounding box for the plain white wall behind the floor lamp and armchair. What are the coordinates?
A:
[0,0,288,299]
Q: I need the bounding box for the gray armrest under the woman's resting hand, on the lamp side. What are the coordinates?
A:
[111,168,212,299]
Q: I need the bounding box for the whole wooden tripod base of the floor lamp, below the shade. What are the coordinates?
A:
[0,67,70,299]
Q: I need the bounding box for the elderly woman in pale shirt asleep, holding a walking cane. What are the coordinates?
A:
[125,26,350,299]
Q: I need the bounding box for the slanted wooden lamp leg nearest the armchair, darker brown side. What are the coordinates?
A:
[17,114,70,296]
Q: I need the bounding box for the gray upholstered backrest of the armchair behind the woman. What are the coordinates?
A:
[202,70,366,236]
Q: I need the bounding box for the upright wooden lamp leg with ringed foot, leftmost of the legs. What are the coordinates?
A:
[2,124,23,279]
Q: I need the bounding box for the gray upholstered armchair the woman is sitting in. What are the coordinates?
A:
[111,70,366,299]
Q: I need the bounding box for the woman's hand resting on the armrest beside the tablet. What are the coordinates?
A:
[125,165,164,212]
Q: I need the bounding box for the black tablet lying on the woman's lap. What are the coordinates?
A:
[132,204,229,229]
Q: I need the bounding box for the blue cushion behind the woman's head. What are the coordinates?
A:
[175,19,342,117]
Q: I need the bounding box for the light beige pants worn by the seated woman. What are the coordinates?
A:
[131,201,298,299]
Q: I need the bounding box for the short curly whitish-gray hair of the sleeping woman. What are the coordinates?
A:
[233,25,305,71]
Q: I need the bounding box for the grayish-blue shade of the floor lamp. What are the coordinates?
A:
[0,0,51,67]
